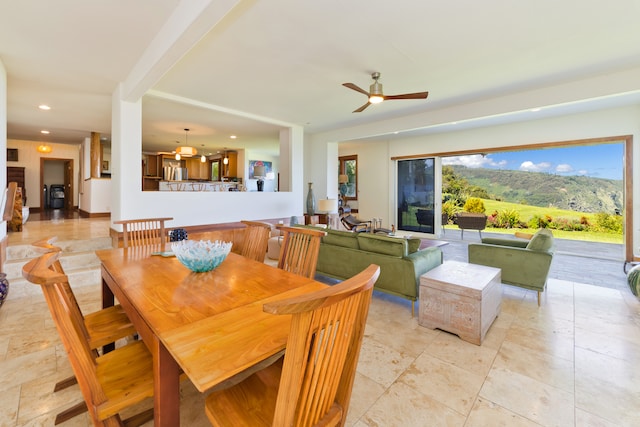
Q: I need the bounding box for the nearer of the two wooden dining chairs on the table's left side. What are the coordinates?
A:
[22,251,153,426]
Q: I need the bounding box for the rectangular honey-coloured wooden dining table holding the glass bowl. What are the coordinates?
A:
[96,246,327,426]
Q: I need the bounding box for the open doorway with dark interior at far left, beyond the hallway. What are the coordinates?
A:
[40,157,75,214]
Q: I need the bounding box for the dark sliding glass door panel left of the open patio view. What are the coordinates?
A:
[396,157,442,234]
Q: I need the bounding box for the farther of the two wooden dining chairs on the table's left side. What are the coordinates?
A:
[32,237,136,425]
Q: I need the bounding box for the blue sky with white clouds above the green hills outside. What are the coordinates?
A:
[442,143,623,180]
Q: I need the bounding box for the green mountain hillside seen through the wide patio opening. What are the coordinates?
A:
[447,165,623,214]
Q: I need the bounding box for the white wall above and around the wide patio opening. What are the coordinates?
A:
[336,105,640,256]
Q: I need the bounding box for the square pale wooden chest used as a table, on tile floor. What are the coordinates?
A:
[418,261,502,345]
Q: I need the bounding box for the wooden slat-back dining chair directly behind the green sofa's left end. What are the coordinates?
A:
[276,225,327,279]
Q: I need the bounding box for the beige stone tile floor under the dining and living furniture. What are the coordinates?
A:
[0,220,640,427]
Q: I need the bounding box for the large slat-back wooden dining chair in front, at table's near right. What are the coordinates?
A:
[205,264,380,427]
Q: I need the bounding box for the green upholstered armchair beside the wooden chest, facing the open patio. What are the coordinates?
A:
[468,228,554,306]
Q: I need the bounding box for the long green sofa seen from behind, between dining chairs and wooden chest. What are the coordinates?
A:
[304,230,442,315]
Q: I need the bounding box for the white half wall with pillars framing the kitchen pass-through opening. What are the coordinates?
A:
[111,87,303,229]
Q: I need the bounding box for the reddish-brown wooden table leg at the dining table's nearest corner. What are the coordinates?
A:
[153,338,180,427]
